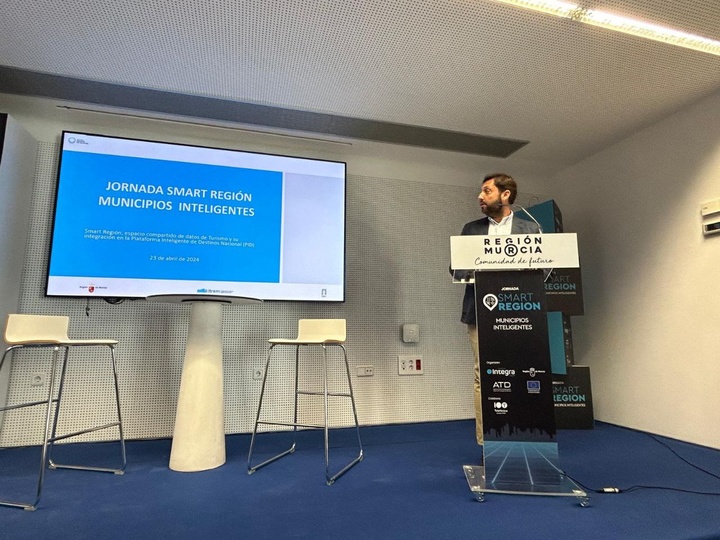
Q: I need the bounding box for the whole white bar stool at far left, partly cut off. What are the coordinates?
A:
[0,314,127,510]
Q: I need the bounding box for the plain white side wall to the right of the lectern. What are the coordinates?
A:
[555,89,720,448]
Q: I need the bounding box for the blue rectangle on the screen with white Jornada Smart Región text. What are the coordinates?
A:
[50,151,283,283]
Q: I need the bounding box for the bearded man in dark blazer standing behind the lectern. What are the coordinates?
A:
[456,173,541,446]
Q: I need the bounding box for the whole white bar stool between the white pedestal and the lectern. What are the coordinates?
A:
[247,319,363,485]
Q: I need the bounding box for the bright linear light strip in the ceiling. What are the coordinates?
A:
[493,0,720,56]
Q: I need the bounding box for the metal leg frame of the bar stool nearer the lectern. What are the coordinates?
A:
[247,343,363,485]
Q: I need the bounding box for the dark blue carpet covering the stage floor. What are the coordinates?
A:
[0,421,720,539]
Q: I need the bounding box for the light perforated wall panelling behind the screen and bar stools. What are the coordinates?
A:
[0,143,540,445]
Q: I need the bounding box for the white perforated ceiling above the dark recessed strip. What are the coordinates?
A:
[0,0,720,164]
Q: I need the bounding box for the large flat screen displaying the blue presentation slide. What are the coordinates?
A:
[46,131,346,302]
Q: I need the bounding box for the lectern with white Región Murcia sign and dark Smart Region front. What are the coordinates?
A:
[450,233,587,505]
